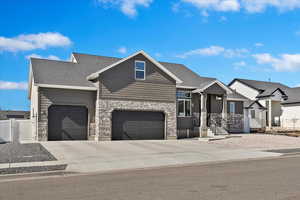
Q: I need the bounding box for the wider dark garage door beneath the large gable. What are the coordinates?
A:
[112,111,165,140]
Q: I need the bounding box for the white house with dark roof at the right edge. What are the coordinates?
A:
[229,79,300,130]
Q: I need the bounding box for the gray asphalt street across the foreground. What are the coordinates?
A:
[0,156,300,200]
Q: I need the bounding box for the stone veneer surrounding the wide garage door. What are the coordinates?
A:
[96,99,177,141]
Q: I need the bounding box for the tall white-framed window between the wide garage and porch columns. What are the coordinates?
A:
[176,91,192,117]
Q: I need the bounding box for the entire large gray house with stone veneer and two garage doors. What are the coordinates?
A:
[28,51,248,141]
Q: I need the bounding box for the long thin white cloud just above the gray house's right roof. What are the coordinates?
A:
[177,46,249,58]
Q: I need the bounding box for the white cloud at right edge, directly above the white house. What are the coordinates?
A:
[253,53,300,71]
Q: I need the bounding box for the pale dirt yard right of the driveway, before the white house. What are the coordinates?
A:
[210,134,300,149]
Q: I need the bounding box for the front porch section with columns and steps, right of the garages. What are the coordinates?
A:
[177,83,244,138]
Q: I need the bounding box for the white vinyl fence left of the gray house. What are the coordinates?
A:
[0,119,34,142]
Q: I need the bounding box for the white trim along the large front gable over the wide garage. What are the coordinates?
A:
[87,50,182,83]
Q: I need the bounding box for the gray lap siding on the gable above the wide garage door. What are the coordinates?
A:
[99,55,176,102]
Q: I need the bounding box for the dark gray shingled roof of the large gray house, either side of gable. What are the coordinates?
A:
[31,53,230,93]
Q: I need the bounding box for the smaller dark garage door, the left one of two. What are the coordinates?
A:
[48,105,88,141]
